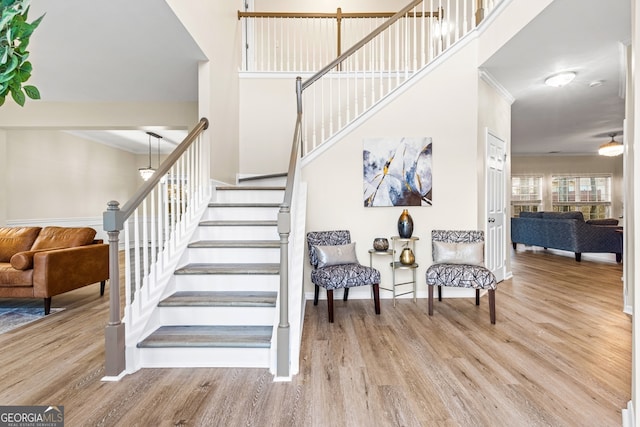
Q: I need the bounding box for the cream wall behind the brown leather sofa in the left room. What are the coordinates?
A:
[5,130,142,223]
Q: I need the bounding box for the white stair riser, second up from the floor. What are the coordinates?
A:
[158,306,275,326]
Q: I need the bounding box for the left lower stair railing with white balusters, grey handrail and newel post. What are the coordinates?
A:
[103,118,211,379]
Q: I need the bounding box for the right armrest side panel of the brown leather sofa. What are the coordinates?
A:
[33,244,109,298]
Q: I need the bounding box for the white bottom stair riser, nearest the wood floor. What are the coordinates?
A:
[140,347,271,368]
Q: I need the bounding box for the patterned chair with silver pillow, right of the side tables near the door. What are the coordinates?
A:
[426,230,498,324]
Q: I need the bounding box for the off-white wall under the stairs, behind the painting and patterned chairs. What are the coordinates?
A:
[303,41,480,297]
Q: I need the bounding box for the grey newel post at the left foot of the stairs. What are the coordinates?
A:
[102,200,126,377]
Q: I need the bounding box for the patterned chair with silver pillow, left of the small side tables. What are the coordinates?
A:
[307,230,380,323]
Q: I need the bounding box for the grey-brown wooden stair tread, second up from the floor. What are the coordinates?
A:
[158,291,277,307]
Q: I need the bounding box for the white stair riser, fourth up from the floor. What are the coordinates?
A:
[181,248,280,264]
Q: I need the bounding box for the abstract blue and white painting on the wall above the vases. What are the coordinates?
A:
[362,137,433,207]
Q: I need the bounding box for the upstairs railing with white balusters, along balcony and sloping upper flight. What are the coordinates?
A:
[238,0,501,155]
